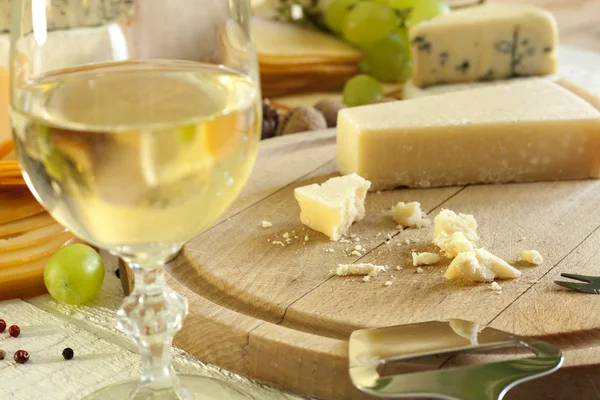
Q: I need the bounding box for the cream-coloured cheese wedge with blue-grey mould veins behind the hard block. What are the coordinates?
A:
[410,3,558,87]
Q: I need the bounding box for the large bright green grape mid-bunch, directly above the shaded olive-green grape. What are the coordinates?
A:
[342,1,399,47]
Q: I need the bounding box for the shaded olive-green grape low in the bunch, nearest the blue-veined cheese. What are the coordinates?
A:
[359,33,408,82]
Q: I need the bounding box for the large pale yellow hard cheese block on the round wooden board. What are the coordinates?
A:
[337,80,600,189]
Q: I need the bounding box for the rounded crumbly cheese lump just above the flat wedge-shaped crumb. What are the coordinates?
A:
[432,209,479,258]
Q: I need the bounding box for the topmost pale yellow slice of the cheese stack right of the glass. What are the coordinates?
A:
[252,18,362,62]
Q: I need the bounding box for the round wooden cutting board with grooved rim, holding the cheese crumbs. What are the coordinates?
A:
[168,131,600,399]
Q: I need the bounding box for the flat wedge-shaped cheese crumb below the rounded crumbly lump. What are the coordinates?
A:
[444,249,521,282]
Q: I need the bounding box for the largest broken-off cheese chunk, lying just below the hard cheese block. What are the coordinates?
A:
[294,174,371,241]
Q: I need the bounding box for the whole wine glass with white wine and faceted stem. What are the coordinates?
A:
[11,0,262,399]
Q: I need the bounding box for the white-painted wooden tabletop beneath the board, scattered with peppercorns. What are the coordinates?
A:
[0,0,600,400]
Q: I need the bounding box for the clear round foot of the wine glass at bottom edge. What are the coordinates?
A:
[84,375,255,400]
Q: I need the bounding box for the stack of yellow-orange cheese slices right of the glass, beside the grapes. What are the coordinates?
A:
[252,18,362,97]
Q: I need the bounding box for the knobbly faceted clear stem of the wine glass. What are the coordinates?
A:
[117,257,187,399]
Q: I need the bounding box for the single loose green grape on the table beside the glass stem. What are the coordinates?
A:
[44,243,104,304]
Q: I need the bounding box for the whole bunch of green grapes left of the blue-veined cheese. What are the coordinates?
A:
[324,0,450,105]
